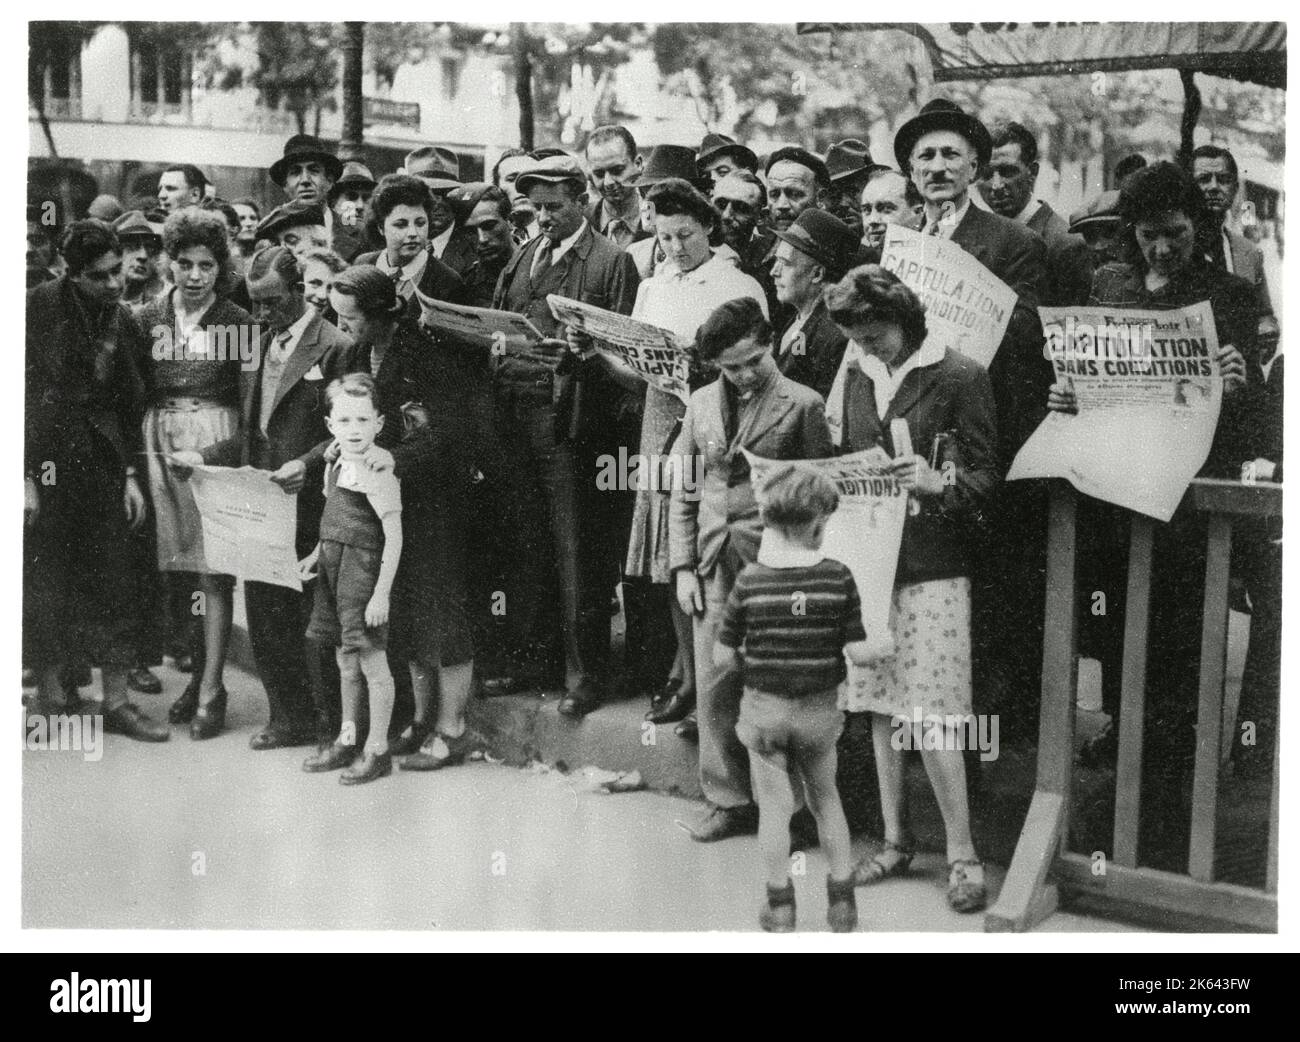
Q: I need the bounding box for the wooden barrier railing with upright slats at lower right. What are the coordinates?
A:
[984,479,1282,932]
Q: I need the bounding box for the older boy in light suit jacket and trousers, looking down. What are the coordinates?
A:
[668,298,832,842]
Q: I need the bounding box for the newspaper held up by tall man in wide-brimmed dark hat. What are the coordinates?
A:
[880,225,1015,369]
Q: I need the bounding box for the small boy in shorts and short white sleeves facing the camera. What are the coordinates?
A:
[299,373,402,785]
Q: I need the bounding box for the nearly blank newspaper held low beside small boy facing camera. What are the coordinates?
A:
[190,466,303,590]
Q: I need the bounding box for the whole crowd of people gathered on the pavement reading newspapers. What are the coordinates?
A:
[23,99,1282,930]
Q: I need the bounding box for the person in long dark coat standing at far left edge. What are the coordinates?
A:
[22,221,168,742]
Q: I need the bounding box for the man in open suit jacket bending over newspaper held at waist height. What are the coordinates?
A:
[203,246,351,750]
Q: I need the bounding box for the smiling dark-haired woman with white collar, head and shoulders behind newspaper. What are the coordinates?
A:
[352,174,469,316]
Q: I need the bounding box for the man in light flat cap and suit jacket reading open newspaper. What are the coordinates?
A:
[488,156,638,716]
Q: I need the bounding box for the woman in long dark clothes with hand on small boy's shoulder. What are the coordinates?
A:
[329,266,482,770]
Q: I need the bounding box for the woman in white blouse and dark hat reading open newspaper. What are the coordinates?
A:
[601,178,767,724]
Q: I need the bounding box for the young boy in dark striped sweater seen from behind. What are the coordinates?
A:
[714,464,875,933]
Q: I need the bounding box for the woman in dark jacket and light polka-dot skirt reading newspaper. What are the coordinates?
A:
[826,265,1001,912]
